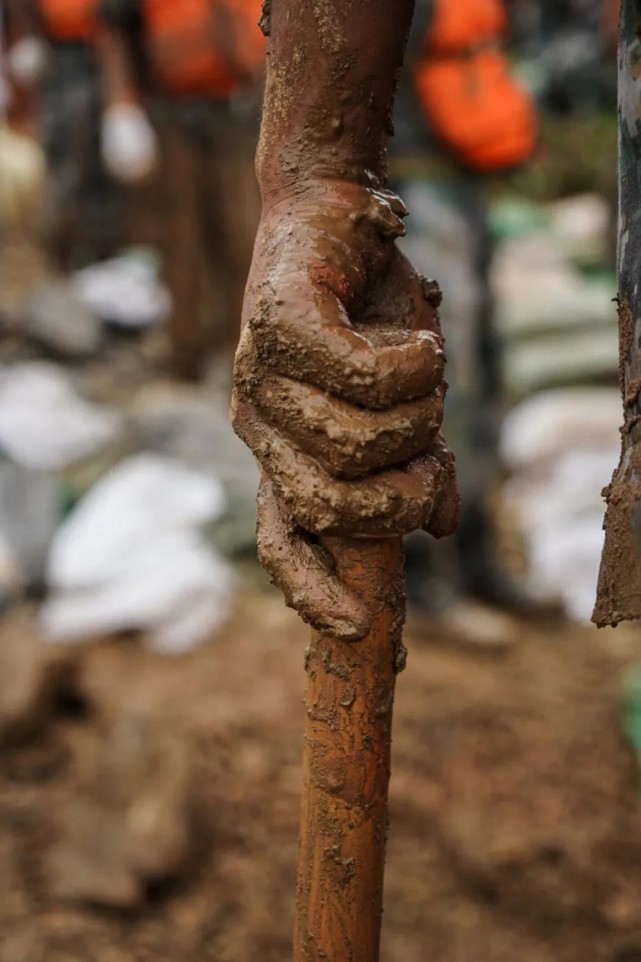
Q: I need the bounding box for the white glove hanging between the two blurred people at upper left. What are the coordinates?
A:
[101,104,158,184]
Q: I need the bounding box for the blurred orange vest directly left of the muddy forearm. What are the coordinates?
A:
[143,0,265,98]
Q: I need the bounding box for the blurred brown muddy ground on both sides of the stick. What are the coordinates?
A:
[0,585,641,962]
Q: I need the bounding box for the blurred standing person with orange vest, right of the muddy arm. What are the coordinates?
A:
[390,0,547,613]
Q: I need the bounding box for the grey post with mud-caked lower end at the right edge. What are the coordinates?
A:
[593,0,641,626]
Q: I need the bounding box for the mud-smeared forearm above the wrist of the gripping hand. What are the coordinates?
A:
[257,0,414,200]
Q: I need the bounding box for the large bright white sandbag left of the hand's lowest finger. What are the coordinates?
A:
[40,454,233,654]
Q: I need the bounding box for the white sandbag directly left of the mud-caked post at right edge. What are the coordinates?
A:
[501,388,621,621]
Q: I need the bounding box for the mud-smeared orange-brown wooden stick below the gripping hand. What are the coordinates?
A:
[294,538,404,962]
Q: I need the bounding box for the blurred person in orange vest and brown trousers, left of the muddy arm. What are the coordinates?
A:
[95,0,264,380]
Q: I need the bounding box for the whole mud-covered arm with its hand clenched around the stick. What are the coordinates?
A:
[232,0,458,640]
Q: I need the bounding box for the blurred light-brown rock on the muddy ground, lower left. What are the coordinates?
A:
[48,709,192,909]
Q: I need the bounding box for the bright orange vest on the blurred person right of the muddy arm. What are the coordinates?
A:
[413,0,537,173]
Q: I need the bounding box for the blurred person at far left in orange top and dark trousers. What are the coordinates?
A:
[7,0,127,271]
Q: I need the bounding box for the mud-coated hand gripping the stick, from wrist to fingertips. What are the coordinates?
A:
[232,181,458,640]
